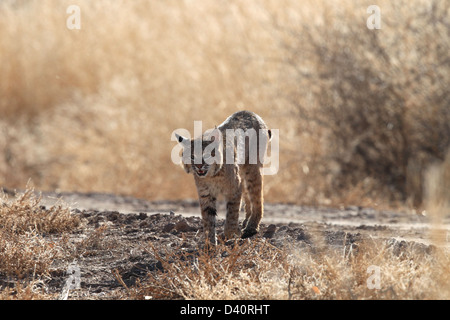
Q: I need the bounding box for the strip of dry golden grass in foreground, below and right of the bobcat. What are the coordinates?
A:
[127,240,450,300]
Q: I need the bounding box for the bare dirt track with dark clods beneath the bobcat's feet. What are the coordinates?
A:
[37,193,450,299]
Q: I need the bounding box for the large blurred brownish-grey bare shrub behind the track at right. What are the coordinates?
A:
[274,0,450,206]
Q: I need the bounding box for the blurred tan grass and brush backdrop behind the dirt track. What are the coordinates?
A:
[0,0,450,208]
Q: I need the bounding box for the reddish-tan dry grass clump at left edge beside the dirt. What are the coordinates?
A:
[0,188,79,299]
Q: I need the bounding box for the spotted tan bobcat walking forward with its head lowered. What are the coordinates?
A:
[175,111,271,244]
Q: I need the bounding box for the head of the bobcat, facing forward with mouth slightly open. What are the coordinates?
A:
[175,129,222,178]
